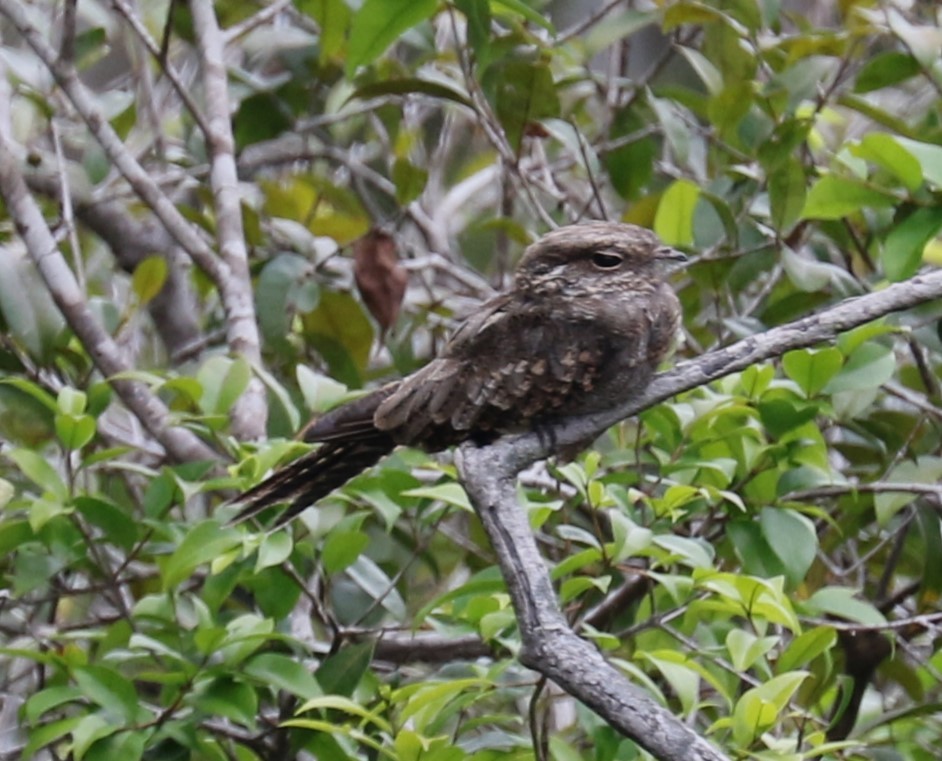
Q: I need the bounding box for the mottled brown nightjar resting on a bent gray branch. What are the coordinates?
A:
[235,222,685,525]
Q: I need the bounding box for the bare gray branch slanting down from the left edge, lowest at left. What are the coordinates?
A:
[0,133,218,462]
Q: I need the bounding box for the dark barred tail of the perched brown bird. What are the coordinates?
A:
[232,432,395,527]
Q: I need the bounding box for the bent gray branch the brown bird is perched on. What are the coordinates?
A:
[458,270,942,761]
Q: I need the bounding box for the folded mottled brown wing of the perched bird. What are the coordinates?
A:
[374,297,624,442]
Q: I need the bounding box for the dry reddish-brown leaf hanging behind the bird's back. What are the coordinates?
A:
[353,230,409,334]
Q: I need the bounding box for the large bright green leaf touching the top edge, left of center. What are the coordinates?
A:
[346,0,438,77]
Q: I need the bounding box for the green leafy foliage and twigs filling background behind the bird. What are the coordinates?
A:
[0,0,942,761]
